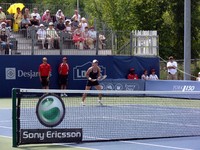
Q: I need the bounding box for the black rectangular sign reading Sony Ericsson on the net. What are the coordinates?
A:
[20,128,83,144]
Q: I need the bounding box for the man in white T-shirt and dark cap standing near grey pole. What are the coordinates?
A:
[167,56,178,80]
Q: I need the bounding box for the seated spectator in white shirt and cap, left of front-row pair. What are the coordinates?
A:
[36,24,47,49]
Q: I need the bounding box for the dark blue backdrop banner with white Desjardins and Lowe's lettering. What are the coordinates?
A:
[0,55,159,98]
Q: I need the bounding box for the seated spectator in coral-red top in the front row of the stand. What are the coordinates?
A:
[73,25,84,49]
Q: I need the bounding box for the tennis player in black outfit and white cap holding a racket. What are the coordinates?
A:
[82,59,102,106]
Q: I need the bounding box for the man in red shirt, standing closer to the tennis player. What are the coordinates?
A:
[58,57,69,96]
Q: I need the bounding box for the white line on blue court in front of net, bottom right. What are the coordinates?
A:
[120,141,193,150]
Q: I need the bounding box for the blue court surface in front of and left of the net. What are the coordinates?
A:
[0,108,200,150]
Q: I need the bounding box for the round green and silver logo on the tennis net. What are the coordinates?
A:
[36,94,65,127]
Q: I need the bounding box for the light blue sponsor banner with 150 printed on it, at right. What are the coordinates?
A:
[145,80,200,99]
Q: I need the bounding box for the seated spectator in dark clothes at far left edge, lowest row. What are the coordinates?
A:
[0,29,13,54]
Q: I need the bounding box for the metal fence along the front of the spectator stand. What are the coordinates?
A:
[1,27,158,56]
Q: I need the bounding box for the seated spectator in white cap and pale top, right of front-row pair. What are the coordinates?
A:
[47,22,60,49]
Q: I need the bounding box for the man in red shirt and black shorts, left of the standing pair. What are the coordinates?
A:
[39,57,51,89]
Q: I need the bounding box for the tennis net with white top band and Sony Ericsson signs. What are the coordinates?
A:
[13,89,200,147]
